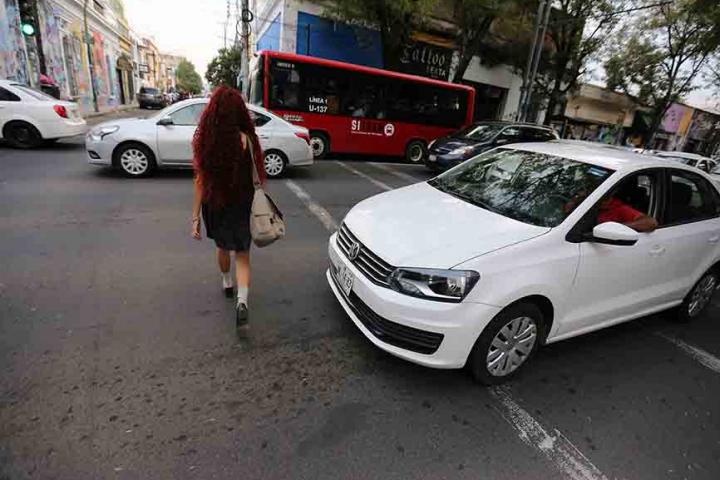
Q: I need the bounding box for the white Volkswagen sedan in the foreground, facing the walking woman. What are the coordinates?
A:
[327,141,720,384]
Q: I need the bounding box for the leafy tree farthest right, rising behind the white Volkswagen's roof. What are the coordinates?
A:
[605,0,720,144]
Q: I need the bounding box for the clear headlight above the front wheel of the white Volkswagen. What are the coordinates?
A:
[390,268,480,302]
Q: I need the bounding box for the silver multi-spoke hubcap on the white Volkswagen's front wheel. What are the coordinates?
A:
[486,317,537,377]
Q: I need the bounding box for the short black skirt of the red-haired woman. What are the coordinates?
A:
[202,202,252,252]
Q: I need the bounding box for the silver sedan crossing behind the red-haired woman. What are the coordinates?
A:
[85,98,313,177]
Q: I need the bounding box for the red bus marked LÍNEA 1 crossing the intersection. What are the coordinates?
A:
[247,51,475,162]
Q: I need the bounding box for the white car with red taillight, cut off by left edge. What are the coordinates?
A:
[0,80,87,148]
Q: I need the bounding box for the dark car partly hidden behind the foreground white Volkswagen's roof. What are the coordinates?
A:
[425,122,558,170]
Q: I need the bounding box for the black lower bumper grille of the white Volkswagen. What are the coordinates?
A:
[331,268,445,355]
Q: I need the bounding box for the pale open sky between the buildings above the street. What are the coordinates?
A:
[124,0,235,78]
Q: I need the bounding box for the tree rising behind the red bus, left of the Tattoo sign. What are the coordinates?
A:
[326,0,437,70]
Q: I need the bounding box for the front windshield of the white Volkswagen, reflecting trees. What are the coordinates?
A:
[429,149,613,227]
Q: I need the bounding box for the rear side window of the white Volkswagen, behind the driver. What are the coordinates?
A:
[663,170,720,225]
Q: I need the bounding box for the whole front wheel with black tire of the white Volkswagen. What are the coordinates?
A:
[467,303,544,385]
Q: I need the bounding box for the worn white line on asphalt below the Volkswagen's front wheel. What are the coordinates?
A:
[490,387,608,480]
